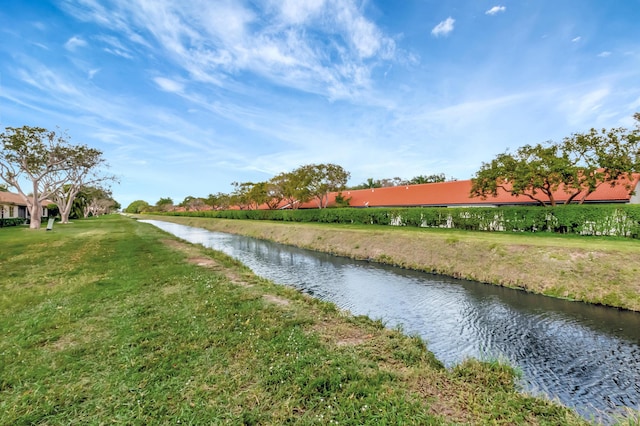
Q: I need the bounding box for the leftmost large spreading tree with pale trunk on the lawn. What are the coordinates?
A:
[0,126,88,229]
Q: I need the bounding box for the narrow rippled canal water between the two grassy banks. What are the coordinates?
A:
[142,221,640,423]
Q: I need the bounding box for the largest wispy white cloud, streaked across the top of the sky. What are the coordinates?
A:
[61,0,396,99]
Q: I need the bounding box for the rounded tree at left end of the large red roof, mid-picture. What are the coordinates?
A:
[297,163,350,209]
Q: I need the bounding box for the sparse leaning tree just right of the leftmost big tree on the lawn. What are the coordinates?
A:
[51,146,116,223]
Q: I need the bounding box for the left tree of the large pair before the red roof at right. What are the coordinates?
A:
[471,144,574,206]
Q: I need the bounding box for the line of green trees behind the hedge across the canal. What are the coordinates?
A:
[126,113,640,213]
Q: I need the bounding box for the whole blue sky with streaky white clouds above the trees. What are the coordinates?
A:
[0,0,640,207]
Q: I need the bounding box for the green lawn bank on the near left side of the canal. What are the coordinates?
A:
[0,216,584,425]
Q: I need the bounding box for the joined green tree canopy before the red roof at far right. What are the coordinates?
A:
[471,114,640,206]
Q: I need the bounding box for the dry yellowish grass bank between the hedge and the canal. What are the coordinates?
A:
[145,216,640,311]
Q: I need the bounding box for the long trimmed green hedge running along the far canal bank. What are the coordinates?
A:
[156,204,640,238]
